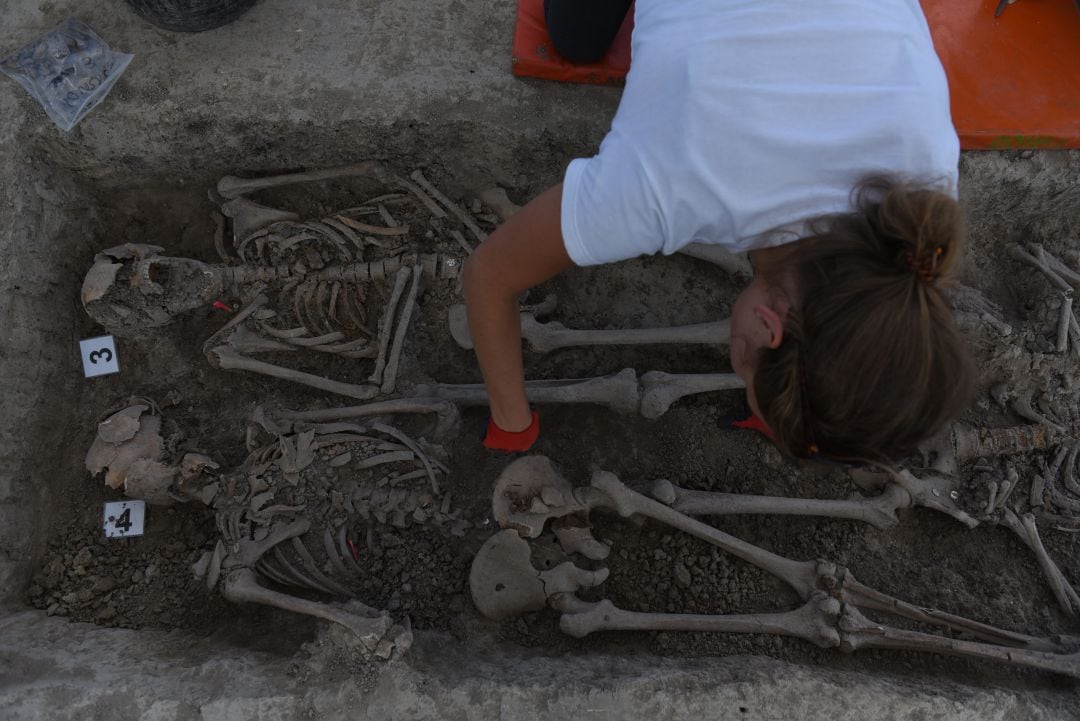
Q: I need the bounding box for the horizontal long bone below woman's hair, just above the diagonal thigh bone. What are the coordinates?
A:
[651,480,912,529]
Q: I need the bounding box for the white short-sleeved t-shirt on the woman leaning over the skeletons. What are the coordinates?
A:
[562,0,959,266]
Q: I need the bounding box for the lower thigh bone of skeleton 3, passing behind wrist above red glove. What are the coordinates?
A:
[413,368,638,413]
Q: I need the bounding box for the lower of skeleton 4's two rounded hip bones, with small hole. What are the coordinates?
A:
[469,530,608,621]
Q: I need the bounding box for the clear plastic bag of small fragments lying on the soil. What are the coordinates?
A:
[0,17,134,132]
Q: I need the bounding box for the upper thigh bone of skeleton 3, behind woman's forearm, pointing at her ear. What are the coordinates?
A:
[449,309,731,353]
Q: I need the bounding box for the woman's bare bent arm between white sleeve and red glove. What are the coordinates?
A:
[464,183,573,432]
